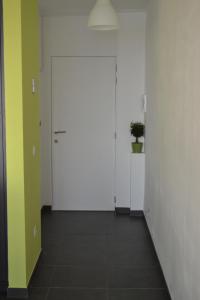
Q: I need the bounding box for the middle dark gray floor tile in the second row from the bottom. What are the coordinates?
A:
[51,267,107,288]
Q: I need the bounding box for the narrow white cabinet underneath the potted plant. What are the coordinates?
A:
[131,153,145,211]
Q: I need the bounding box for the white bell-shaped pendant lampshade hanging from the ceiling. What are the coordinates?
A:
[88,0,119,30]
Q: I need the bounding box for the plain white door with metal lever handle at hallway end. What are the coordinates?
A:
[52,57,116,210]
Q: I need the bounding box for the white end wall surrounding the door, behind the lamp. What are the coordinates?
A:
[41,12,145,206]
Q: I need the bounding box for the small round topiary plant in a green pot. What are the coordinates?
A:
[130,122,145,153]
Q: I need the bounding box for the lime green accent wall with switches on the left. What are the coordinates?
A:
[3,0,41,288]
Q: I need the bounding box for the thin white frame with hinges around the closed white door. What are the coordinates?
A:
[51,55,118,211]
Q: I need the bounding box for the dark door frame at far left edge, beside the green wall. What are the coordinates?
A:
[0,0,8,293]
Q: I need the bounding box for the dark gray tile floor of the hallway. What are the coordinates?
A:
[11,212,170,300]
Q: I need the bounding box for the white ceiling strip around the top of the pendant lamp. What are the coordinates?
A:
[39,0,148,16]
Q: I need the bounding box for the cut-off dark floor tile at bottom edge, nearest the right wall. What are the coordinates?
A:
[109,289,170,300]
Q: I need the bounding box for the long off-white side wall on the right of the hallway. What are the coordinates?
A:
[145,0,200,300]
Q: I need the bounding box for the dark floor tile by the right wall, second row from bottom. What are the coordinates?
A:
[109,267,166,289]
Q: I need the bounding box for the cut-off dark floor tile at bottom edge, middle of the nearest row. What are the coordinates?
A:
[47,288,107,300]
